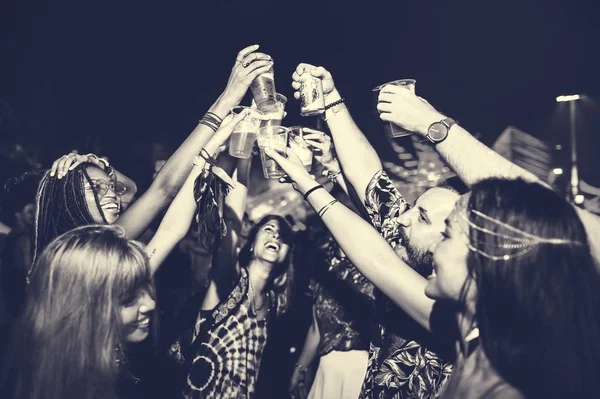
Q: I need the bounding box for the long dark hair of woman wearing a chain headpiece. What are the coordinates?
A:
[467,179,600,398]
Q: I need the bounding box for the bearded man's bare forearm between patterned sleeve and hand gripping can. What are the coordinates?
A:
[325,90,382,201]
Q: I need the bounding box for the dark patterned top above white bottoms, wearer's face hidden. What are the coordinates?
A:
[310,238,373,356]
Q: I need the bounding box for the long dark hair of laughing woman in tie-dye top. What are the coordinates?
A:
[238,215,294,317]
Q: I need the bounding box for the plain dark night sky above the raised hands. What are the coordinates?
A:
[0,0,600,184]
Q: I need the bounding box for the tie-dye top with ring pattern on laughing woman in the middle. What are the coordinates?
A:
[170,268,267,399]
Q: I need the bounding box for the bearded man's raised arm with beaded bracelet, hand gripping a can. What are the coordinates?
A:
[292,64,382,202]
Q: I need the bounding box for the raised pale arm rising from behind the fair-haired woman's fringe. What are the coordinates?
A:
[146,114,243,273]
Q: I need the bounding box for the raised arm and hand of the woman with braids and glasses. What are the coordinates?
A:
[116,45,273,238]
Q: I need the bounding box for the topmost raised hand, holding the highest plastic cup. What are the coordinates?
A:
[224,44,273,105]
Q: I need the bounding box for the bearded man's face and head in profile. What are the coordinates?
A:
[396,187,459,276]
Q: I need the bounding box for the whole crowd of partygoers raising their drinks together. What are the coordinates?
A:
[0,46,600,399]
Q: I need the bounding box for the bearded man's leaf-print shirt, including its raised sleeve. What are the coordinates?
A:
[360,171,452,399]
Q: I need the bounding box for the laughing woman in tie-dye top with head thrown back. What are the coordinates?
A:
[169,155,293,398]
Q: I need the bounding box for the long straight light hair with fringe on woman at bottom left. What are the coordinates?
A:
[5,225,154,399]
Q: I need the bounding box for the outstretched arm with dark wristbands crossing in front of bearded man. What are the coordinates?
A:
[267,150,434,329]
